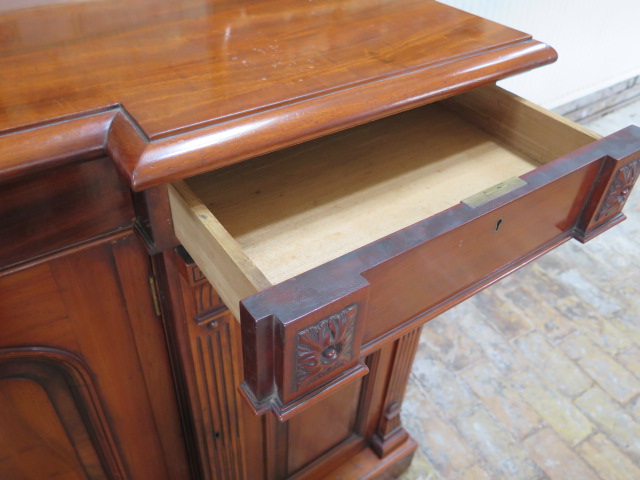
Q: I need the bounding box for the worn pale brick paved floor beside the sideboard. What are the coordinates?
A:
[401,98,640,480]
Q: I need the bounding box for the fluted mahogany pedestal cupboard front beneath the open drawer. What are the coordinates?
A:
[158,251,420,480]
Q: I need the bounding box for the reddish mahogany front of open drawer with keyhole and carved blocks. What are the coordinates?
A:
[240,119,640,417]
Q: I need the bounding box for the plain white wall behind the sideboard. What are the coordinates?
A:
[440,0,640,108]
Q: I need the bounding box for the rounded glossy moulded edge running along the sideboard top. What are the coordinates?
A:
[0,40,557,191]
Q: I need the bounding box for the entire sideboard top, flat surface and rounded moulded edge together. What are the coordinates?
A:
[0,0,556,190]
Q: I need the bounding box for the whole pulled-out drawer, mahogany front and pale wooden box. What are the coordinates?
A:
[170,86,640,419]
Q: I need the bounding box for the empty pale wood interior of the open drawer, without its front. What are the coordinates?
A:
[172,86,597,316]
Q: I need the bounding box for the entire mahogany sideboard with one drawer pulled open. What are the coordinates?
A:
[0,0,640,480]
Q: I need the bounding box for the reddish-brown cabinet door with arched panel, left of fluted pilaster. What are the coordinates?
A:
[0,234,189,480]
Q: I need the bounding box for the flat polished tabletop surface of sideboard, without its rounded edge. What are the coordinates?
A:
[0,0,544,139]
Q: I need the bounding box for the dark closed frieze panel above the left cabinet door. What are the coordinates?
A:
[0,158,134,268]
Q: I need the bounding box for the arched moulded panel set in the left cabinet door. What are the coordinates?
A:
[0,346,132,479]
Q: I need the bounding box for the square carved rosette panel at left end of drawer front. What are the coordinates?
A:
[296,305,358,389]
